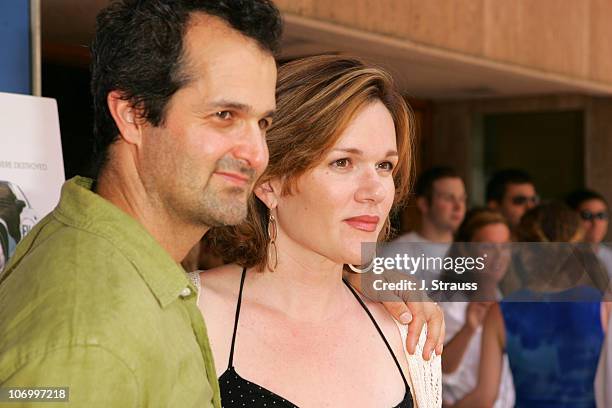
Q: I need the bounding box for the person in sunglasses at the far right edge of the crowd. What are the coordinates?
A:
[566,189,612,277]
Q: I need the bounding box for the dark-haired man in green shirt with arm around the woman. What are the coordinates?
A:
[0,0,443,407]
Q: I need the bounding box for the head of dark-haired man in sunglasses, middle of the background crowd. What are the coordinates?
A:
[486,169,540,228]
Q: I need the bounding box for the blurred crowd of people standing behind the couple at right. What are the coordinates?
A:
[396,167,612,408]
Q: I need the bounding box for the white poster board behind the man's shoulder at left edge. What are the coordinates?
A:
[0,92,65,270]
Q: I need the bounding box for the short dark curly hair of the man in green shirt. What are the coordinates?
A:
[91,0,282,174]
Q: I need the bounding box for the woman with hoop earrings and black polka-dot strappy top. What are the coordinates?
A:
[191,56,440,407]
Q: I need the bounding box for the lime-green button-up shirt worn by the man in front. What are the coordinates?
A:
[0,177,220,408]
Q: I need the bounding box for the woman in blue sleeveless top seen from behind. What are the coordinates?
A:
[455,202,606,408]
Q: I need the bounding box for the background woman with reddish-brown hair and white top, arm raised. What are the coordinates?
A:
[440,208,514,408]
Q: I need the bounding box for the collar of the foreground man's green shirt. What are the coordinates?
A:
[53,176,195,307]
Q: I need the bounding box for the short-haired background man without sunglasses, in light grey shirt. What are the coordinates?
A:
[395,167,467,279]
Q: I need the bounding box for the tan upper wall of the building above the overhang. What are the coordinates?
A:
[275,0,612,84]
